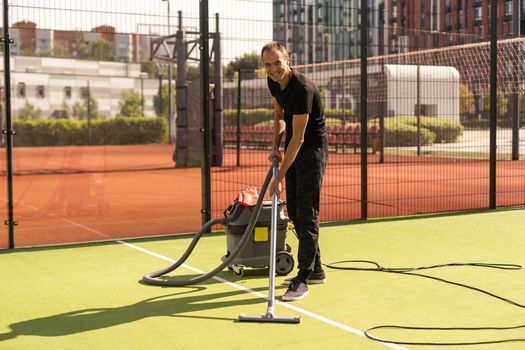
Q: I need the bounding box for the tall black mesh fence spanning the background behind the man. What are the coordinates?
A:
[0,0,525,247]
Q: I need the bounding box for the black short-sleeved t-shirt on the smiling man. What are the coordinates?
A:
[267,70,327,148]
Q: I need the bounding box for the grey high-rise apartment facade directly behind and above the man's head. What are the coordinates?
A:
[273,0,383,64]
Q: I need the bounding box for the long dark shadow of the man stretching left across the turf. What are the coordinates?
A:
[0,286,286,341]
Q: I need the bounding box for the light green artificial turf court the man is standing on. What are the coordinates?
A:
[0,209,525,349]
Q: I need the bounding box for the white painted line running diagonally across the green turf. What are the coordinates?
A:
[116,238,407,350]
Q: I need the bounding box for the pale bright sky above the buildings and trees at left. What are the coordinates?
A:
[9,0,272,62]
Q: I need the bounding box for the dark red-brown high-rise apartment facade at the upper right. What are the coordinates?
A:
[385,0,525,53]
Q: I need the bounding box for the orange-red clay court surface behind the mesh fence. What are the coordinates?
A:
[0,145,525,248]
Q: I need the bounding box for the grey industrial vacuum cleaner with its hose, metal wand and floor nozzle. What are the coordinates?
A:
[142,157,300,323]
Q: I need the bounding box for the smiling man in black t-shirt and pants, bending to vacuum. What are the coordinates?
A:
[261,42,328,301]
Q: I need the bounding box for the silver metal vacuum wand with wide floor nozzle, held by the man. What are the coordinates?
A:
[239,157,301,323]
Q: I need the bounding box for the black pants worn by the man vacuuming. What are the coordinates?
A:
[286,146,328,271]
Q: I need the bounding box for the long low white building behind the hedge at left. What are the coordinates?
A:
[0,55,159,118]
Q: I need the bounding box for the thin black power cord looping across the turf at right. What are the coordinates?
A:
[323,260,525,346]
